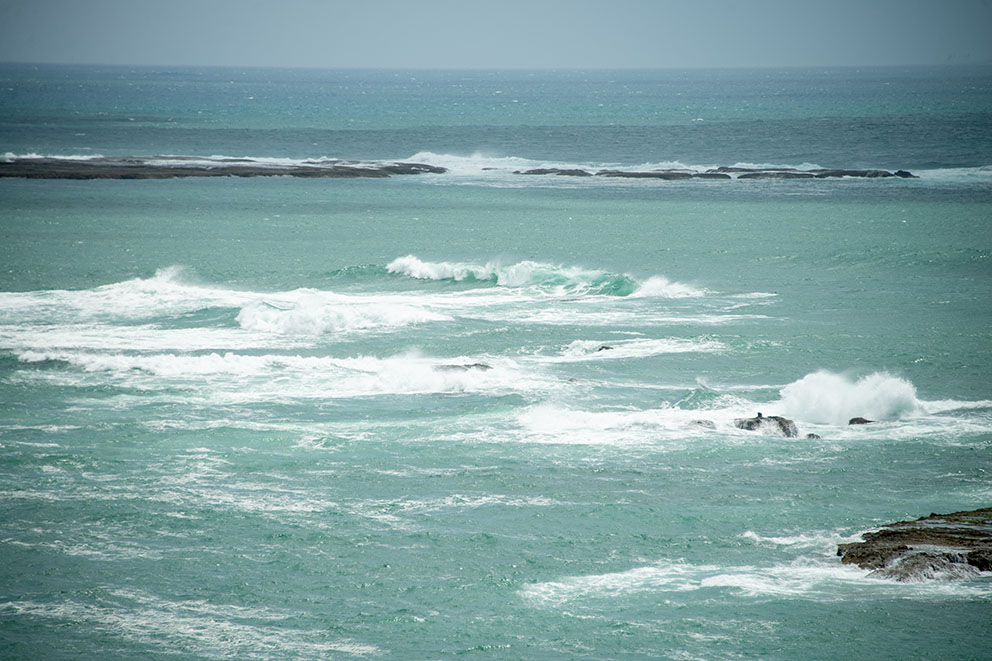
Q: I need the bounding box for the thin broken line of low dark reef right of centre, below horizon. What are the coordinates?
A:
[514,167,919,181]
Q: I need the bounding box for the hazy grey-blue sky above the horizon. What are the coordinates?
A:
[0,0,992,69]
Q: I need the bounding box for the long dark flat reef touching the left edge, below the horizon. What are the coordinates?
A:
[0,156,447,179]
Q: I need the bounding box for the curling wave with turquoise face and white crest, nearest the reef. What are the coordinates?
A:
[386,255,706,298]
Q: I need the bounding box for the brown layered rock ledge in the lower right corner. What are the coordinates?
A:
[837,507,992,581]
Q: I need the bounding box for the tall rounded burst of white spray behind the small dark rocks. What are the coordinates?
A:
[780,371,922,425]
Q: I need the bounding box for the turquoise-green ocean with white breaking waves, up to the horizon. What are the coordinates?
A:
[0,64,992,660]
